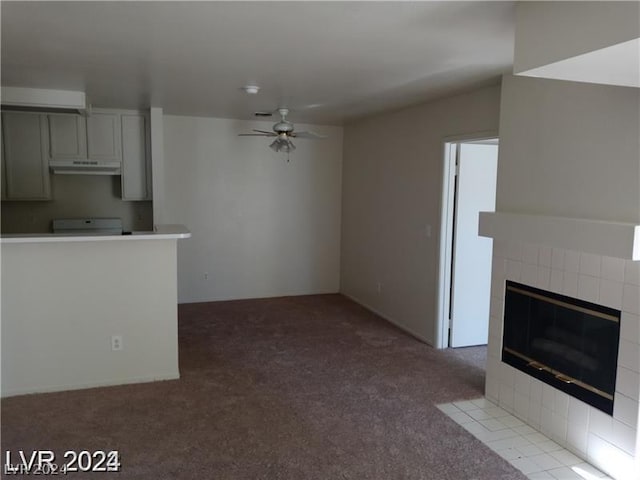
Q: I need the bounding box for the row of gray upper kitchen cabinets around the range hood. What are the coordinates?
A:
[0,109,152,201]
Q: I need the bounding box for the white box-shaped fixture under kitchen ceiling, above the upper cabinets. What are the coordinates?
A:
[0,86,87,114]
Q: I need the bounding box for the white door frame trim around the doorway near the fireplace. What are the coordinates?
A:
[433,130,499,348]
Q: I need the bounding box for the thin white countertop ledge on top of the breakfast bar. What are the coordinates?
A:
[0,225,191,244]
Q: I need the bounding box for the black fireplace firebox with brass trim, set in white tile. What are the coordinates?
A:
[502,281,620,415]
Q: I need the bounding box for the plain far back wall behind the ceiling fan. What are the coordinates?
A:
[162,115,342,303]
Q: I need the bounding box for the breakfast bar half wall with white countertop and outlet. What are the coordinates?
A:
[0,225,190,397]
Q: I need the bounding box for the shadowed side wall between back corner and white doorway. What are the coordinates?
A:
[341,86,500,344]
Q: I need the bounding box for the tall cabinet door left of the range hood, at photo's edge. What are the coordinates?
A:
[2,112,51,200]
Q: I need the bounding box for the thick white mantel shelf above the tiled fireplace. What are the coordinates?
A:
[478,212,640,260]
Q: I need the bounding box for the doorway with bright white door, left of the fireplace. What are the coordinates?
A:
[436,136,498,348]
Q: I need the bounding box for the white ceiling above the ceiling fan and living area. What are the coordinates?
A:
[0,1,514,124]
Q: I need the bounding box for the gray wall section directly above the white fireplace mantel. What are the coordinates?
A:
[496,76,640,223]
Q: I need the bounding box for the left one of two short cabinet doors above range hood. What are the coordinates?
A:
[49,113,87,160]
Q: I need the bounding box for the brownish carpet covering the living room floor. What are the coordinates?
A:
[1,295,526,480]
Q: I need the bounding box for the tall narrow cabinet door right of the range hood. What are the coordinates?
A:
[122,114,151,200]
